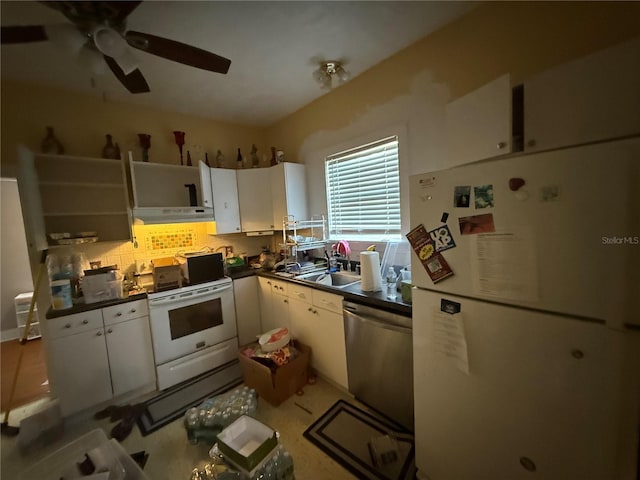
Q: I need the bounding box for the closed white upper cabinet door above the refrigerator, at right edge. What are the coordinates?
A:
[524,37,640,151]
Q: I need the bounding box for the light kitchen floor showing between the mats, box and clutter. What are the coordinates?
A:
[0,378,362,480]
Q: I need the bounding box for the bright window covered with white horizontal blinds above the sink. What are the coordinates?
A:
[325,136,400,240]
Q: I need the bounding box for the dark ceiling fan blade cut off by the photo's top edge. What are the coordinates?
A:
[40,1,142,28]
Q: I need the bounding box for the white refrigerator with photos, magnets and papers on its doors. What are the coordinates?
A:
[410,137,640,480]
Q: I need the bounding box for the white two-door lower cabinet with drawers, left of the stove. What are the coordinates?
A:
[44,299,156,416]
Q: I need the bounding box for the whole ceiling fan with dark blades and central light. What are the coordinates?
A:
[0,1,231,93]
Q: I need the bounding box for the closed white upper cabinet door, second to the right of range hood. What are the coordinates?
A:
[236,168,274,232]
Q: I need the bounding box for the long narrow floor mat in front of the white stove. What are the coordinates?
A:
[137,360,242,436]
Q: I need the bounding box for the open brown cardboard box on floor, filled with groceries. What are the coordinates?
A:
[238,341,311,407]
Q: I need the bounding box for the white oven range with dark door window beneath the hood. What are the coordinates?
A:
[149,277,238,390]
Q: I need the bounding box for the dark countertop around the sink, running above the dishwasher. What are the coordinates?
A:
[254,270,411,317]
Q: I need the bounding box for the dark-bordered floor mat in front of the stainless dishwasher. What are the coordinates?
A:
[304,400,415,480]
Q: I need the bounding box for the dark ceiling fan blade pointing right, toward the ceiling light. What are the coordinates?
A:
[125,31,231,73]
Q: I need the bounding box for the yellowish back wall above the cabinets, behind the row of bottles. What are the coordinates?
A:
[0,79,268,176]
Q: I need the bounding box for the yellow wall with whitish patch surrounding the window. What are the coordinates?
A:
[267,2,640,227]
